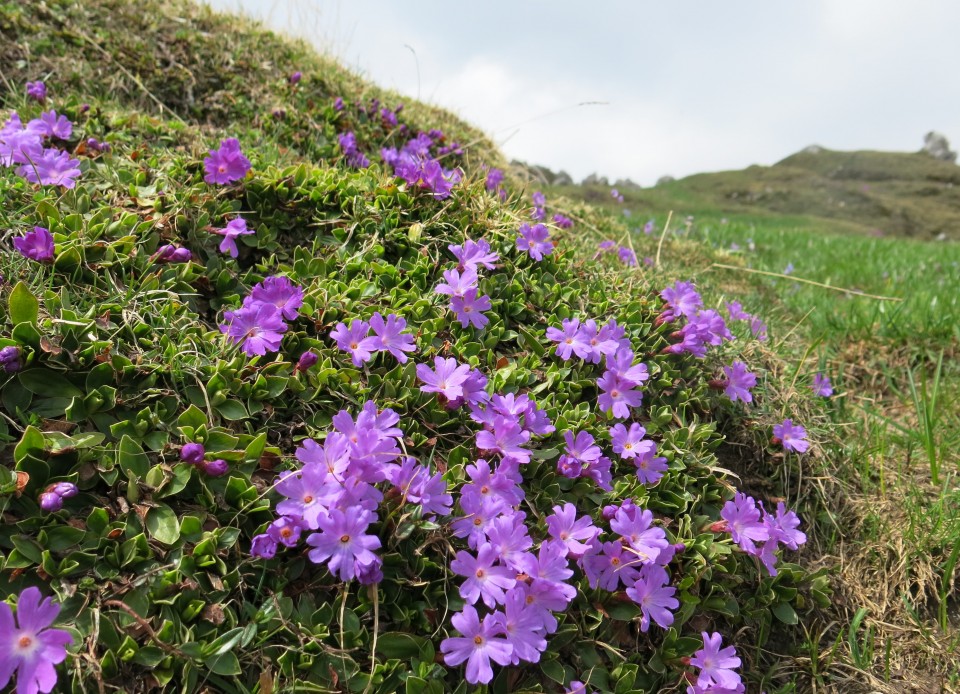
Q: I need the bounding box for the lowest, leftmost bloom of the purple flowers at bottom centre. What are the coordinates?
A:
[440,605,513,684]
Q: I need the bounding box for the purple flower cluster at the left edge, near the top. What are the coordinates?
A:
[0,102,80,188]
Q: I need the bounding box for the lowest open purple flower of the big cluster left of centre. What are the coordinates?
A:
[307,509,380,581]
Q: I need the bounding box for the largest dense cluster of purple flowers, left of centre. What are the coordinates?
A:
[250,401,453,584]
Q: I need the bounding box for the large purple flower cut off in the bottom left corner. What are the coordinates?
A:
[0,586,73,694]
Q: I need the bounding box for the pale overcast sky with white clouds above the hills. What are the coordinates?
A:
[208,0,960,185]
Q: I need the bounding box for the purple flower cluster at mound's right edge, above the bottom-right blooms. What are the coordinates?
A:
[713,492,807,576]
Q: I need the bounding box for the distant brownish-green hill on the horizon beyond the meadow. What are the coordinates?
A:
[544,147,960,240]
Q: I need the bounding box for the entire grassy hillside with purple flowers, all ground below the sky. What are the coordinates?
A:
[0,0,960,694]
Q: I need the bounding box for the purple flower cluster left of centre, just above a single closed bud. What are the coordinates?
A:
[220,275,303,357]
